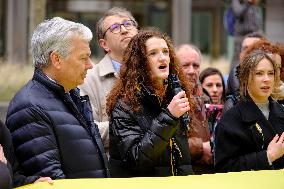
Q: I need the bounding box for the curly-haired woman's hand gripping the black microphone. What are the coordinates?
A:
[168,91,190,118]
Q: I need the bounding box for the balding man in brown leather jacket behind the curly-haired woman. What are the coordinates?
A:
[175,44,213,174]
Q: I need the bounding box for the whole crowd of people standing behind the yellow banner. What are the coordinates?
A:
[0,3,284,189]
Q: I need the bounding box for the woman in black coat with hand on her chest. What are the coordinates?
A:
[214,50,284,172]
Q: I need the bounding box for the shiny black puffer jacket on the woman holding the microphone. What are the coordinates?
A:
[110,87,193,177]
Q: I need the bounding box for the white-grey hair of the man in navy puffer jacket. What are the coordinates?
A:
[31,17,93,68]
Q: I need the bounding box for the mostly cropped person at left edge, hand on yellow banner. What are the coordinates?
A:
[0,120,53,189]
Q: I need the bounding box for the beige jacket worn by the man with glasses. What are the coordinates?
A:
[79,54,118,153]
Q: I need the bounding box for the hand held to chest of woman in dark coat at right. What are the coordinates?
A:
[267,132,284,162]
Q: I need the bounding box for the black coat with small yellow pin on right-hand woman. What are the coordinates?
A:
[214,99,284,172]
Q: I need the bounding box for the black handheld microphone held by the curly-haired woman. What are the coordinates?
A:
[168,74,190,131]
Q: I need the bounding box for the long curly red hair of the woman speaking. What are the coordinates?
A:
[107,28,195,116]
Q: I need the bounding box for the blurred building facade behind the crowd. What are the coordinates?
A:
[0,0,284,63]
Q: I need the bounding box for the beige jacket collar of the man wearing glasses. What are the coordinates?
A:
[97,54,118,77]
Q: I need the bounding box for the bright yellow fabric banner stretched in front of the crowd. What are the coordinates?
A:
[17,169,284,189]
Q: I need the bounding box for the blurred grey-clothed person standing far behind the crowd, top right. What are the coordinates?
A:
[231,0,263,68]
